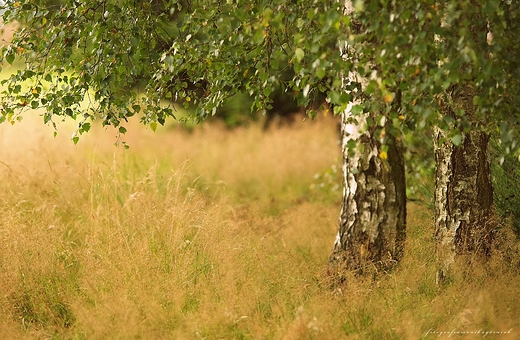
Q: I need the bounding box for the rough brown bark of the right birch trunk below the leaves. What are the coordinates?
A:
[434,87,495,284]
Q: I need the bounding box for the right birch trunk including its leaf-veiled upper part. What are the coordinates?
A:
[434,1,517,283]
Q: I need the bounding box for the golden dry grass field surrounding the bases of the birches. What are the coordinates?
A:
[0,113,520,339]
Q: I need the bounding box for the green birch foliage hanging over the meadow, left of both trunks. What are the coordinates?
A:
[2,0,348,137]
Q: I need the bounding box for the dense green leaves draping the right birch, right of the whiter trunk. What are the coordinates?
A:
[348,0,520,151]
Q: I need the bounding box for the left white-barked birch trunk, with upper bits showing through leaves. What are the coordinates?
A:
[331,1,406,272]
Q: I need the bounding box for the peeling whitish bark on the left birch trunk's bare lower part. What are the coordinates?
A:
[331,110,406,273]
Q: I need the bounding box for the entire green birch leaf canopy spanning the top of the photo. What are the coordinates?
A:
[0,0,520,151]
